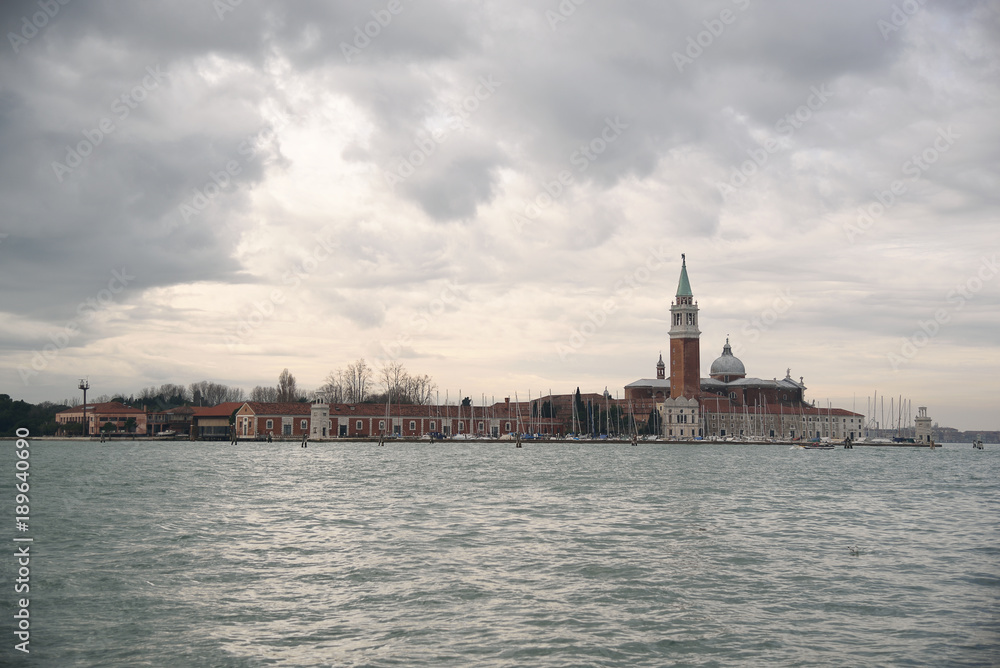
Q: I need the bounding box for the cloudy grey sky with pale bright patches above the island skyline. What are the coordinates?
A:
[0,0,1000,430]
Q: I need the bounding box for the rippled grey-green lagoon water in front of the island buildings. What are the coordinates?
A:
[0,441,1000,667]
